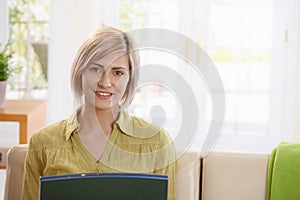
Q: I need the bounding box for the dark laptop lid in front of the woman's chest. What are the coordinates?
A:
[40,173,168,200]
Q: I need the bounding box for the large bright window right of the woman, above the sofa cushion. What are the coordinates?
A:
[207,0,274,135]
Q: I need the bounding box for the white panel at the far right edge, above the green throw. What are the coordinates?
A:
[269,0,300,141]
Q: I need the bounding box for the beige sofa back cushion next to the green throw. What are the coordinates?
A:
[202,152,269,200]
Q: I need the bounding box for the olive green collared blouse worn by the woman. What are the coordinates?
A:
[22,111,177,200]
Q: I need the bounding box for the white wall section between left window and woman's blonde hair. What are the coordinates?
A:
[47,0,116,123]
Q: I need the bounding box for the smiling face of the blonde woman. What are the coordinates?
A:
[82,54,130,110]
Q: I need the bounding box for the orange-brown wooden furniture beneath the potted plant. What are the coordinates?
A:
[0,100,46,144]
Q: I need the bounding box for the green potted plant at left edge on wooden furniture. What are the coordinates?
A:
[0,43,13,108]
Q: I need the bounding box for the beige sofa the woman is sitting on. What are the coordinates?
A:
[4,145,269,200]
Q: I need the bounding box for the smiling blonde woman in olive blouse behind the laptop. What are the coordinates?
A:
[22,27,177,200]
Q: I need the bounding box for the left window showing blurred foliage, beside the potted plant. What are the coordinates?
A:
[7,0,50,98]
